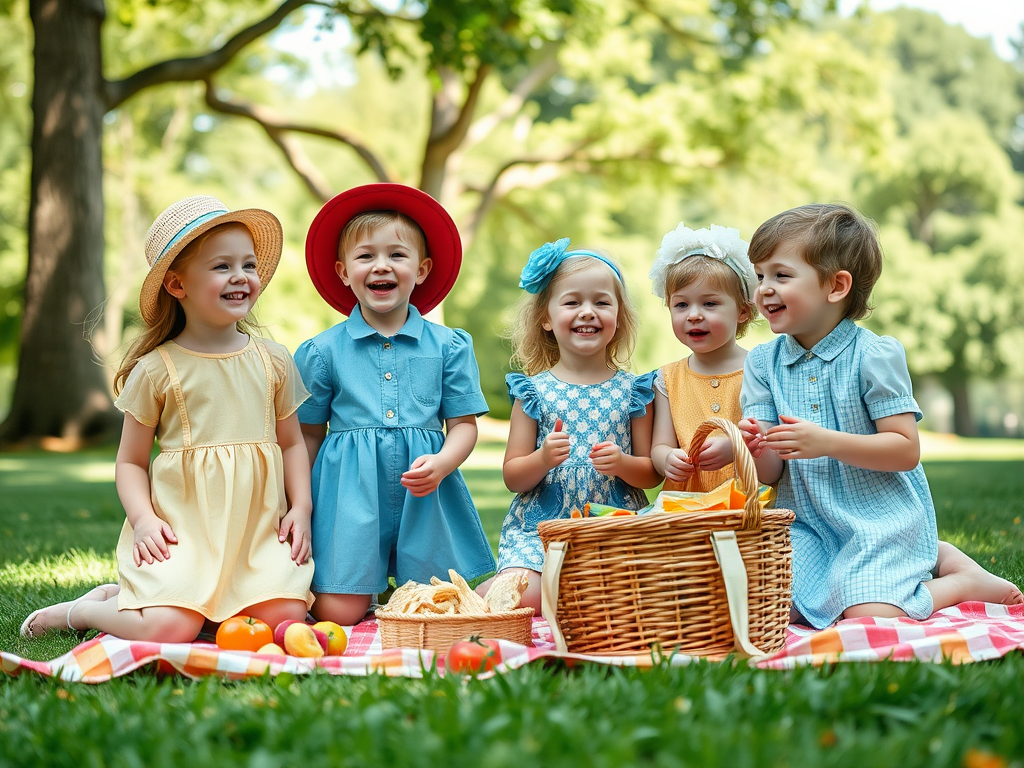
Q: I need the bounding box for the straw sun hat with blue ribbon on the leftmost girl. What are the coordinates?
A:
[138,196,284,326]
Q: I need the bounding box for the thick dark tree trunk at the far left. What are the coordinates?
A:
[0,0,120,447]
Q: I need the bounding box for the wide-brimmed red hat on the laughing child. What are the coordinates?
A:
[306,184,462,315]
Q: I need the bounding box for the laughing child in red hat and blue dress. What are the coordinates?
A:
[295,184,495,625]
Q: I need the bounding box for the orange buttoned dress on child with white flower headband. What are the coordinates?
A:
[654,357,743,492]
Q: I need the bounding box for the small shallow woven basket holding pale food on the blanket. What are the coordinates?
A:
[376,608,534,653]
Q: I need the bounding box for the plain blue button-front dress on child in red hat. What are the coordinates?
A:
[295,305,495,595]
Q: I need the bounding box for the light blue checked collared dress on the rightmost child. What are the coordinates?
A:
[740,319,938,628]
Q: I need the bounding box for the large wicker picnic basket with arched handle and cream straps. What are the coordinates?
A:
[539,418,794,656]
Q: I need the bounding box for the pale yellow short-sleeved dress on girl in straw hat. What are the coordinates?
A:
[115,338,313,622]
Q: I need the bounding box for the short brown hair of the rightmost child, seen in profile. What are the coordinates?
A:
[749,203,882,319]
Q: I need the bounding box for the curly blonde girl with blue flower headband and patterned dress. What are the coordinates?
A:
[479,238,662,610]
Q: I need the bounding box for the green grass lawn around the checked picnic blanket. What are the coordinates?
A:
[0,440,1024,768]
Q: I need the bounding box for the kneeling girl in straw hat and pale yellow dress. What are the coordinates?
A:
[22,197,312,642]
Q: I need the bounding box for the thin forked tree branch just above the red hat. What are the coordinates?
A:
[206,80,394,198]
